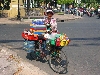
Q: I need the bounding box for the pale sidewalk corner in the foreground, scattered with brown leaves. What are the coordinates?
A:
[0,46,49,75]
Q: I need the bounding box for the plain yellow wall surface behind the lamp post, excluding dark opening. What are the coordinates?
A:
[0,0,25,18]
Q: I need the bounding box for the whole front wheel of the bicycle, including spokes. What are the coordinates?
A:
[49,51,68,73]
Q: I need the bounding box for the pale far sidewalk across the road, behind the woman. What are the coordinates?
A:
[0,14,82,24]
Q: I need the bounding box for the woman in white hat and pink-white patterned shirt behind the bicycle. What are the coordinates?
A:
[45,10,57,31]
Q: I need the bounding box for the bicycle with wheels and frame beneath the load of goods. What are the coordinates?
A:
[30,38,68,73]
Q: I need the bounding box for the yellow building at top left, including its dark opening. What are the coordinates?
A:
[0,0,25,18]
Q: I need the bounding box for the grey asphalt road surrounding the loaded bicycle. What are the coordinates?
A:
[0,17,100,75]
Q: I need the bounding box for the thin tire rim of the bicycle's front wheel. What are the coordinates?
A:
[48,51,68,74]
